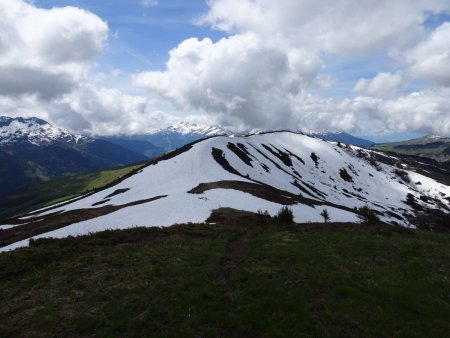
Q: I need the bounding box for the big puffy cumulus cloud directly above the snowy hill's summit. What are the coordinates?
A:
[133,33,323,127]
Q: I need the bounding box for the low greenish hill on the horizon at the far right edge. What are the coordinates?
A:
[373,135,450,162]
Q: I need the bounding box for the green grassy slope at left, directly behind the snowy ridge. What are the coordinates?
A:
[0,163,148,219]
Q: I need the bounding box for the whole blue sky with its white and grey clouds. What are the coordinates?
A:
[0,0,450,141]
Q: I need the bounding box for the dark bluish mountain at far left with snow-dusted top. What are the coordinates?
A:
[0,116,146,195]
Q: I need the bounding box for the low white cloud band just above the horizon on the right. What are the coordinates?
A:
[292,88,450,135]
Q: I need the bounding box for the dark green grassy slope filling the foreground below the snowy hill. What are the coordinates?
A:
[0,218,450,337]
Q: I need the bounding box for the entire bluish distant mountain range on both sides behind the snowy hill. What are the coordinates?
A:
[0,116,450,201]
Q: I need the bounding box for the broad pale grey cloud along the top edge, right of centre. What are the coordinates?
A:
[199,0,449,55]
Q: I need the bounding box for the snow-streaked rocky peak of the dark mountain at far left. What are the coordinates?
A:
[0,116,90,145]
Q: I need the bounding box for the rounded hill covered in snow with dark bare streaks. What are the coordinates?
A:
[0,132,450,250]
